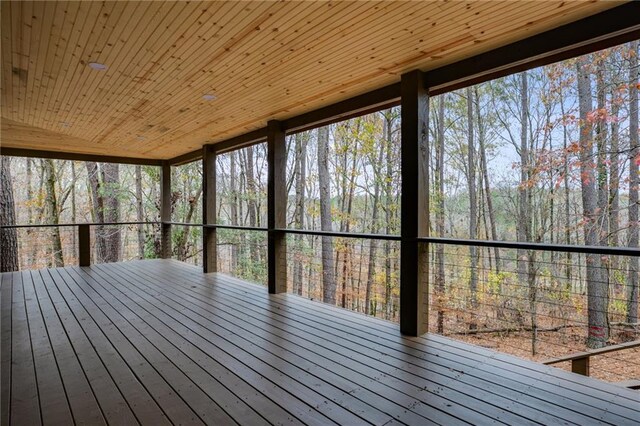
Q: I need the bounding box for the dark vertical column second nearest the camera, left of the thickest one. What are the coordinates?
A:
[267,121,287,293]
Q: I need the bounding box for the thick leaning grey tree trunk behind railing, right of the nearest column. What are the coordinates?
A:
[576,57,609,348]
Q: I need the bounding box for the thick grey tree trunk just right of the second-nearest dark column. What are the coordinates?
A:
[318,126,336,305]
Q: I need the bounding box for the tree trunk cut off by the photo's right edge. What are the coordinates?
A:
[627,41,640,323]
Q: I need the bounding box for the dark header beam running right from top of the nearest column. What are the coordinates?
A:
[427,2,640,96]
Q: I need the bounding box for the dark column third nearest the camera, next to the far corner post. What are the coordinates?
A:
[202,145,218,273]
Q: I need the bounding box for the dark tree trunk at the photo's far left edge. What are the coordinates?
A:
[0,155,20,272]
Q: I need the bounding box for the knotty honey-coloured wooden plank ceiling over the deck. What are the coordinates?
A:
[1,0,619,159]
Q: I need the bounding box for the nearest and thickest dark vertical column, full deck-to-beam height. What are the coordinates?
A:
[400,71,429,336]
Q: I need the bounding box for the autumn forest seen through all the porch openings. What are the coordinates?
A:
[0,41,640,376]
